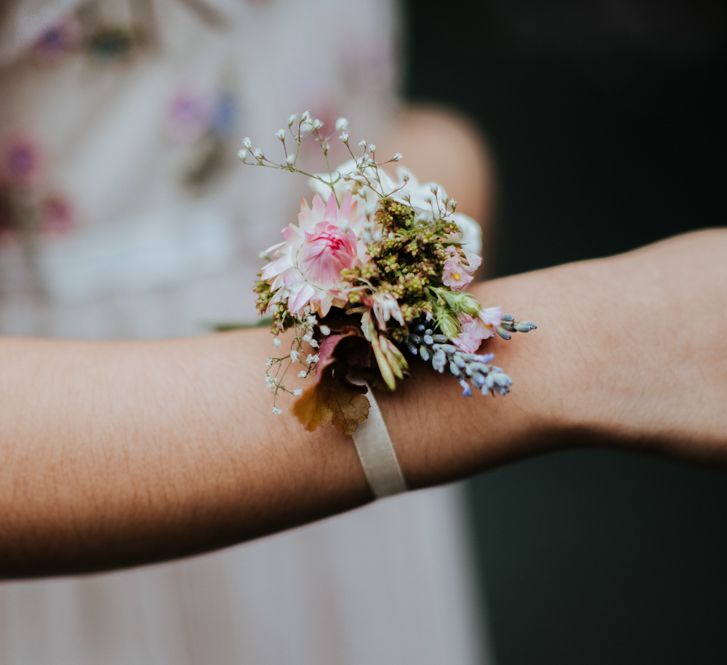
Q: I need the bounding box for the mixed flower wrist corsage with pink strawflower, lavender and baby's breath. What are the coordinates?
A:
[239,111,536,434]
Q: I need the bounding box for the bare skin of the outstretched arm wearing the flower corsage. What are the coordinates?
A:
[0,230,727,577]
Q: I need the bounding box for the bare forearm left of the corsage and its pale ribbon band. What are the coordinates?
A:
[0,330,376,576]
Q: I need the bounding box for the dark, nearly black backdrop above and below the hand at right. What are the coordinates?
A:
[405,0,727,665]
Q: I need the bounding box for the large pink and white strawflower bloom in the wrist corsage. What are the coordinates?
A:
[261,194,365,316]
